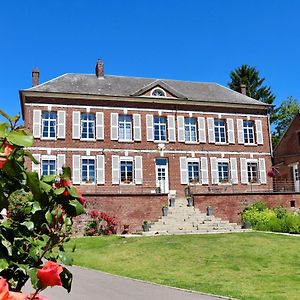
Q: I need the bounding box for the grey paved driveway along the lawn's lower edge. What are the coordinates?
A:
[41,267,224,300]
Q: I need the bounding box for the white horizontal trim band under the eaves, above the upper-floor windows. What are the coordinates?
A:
[25,103,268,118]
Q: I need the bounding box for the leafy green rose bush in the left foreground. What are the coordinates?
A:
[0,111,84,291]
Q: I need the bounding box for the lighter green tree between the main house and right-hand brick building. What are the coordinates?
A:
[272,96,300,148]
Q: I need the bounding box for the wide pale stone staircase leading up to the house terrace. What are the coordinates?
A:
[143,198,245,235]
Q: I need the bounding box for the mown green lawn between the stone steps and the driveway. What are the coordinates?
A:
[69,233,300,300]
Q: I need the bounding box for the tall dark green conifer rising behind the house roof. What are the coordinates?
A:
[228,65,275,104]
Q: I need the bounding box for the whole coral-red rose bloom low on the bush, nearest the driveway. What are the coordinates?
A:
[37,261,63,287]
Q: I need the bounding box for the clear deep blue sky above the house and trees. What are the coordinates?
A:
[0,0,300,120]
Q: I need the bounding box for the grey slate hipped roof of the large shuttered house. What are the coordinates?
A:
[25,74,268,107]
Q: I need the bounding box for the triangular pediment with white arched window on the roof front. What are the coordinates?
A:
[131,80,187,99]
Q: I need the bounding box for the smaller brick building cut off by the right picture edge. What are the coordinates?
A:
[273,113,300,192]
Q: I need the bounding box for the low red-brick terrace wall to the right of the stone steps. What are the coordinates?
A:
[194,193,300,223]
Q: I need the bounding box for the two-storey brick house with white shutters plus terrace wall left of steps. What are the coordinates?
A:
[20,60,272,231]
